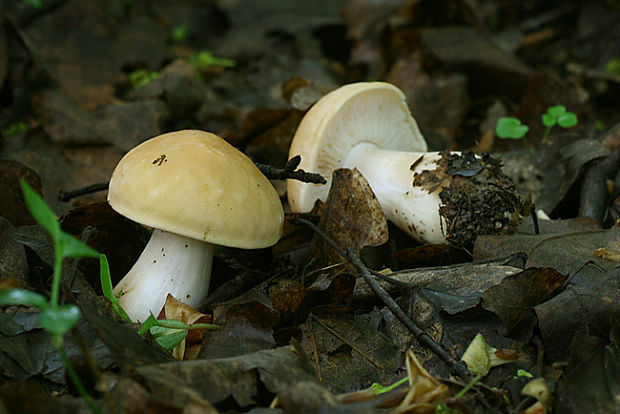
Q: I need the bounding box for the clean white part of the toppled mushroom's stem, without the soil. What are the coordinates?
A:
[344,143,446,244]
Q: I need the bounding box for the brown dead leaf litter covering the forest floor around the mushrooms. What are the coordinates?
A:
[0,0,620,413]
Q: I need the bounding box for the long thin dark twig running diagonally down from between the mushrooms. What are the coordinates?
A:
[293,217,471,382]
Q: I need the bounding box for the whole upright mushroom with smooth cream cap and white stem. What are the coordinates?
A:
[108,130,284,322]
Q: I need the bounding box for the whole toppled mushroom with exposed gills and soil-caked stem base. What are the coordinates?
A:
[287,82,527,247]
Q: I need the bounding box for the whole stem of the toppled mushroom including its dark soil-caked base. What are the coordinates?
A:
[343,143,529,248]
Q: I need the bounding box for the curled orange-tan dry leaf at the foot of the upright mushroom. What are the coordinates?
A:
[157,294,211,361]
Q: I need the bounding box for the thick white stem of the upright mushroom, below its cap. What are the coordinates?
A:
[114,229,214,322]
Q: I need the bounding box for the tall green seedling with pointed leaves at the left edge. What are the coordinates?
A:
[0,180,100,413]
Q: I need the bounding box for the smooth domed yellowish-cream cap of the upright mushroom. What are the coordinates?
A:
[108,130,284,249]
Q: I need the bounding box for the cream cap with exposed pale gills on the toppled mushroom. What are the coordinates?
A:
[287,82,427,211]
